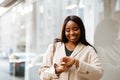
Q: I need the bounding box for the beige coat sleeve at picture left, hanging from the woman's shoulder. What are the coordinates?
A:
[39,44,58,80]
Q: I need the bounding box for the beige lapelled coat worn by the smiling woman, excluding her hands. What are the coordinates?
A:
[40,42,103,80]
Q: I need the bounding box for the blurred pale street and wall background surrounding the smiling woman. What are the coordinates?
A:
[0,0,120,80]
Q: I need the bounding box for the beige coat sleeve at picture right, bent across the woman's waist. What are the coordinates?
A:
[73,47,103,80]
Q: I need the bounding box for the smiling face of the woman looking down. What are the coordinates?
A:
[65,21,80,43]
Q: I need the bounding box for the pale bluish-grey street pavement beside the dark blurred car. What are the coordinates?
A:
[0,58,24,80]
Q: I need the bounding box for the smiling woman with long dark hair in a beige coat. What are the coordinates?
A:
[40,15,103,80]
